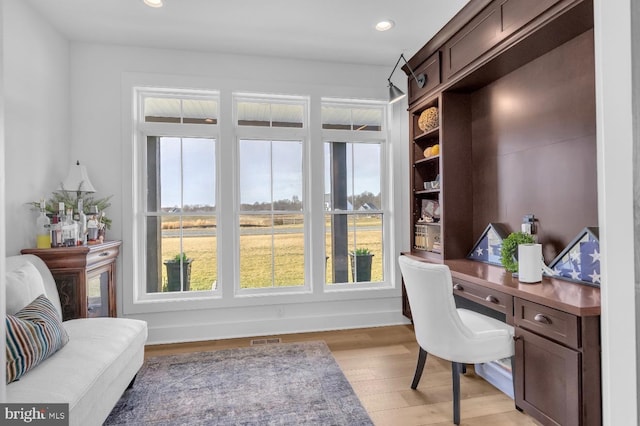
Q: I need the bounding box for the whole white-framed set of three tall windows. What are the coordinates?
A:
[133,88,392,310]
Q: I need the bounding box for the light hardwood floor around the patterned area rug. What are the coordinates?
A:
[145,326,539,426]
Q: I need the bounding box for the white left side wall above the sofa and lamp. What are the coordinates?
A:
[2,0,70,255]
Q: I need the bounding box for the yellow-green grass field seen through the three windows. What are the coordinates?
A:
[161,216,383,290]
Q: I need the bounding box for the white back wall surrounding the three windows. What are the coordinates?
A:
[70,43,408,343]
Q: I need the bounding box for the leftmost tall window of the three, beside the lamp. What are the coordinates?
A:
[141,94,217,295]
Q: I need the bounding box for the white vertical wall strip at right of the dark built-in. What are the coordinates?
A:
[594,0,638,426]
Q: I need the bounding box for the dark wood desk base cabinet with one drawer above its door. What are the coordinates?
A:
[514,298,601,425]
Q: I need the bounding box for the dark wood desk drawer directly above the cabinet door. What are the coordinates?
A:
[514,298,580,349]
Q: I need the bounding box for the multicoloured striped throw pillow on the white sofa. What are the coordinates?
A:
[6,295,69,384]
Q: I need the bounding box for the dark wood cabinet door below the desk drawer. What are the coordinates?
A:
[515,328,582,426]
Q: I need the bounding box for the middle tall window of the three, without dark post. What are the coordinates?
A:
[235,96,307,292]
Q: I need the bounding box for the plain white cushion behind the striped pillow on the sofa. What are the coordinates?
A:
[5,262,45,315]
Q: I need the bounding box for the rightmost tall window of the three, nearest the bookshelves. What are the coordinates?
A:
[322,103,385,284]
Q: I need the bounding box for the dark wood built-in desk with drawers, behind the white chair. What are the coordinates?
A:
[403,253,601,425]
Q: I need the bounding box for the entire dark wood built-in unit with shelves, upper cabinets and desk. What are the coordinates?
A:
[403,0,601,425]
